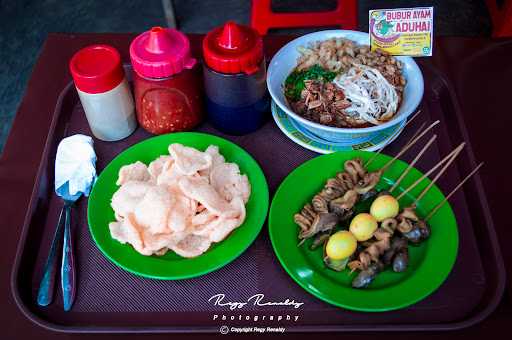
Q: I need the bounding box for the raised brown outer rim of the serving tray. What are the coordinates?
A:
[10,63,506,334]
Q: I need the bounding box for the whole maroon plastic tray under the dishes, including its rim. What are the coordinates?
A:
[11,62,505,332]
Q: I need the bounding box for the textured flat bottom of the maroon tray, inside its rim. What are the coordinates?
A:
[32,96,485,326]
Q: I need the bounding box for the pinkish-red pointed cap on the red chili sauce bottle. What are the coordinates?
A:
[130,27,196,78]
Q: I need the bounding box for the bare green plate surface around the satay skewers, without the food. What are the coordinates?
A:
[269,151,459,312]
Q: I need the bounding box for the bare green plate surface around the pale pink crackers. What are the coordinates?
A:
[87,132,269,280]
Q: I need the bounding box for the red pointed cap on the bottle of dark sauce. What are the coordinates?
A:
[203,21,263,74]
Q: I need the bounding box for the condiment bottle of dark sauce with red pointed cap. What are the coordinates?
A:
[203,21,269,135]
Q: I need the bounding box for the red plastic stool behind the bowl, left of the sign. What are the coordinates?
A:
[251,0,357,35]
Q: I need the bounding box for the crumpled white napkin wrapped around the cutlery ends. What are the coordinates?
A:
[55,135,96,196]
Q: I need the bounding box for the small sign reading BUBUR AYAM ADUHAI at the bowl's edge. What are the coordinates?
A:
[369,7,434,57]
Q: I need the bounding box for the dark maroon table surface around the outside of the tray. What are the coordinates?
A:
[0,34,512,339]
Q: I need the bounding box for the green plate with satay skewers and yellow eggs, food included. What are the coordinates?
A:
[269,131,478,312]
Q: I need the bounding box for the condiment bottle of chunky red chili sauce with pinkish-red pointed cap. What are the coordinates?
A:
[130,27,203,134]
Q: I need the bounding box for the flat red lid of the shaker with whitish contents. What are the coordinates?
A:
[69,45,124,93]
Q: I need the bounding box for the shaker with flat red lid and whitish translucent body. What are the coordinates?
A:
[69,45,137,141]
